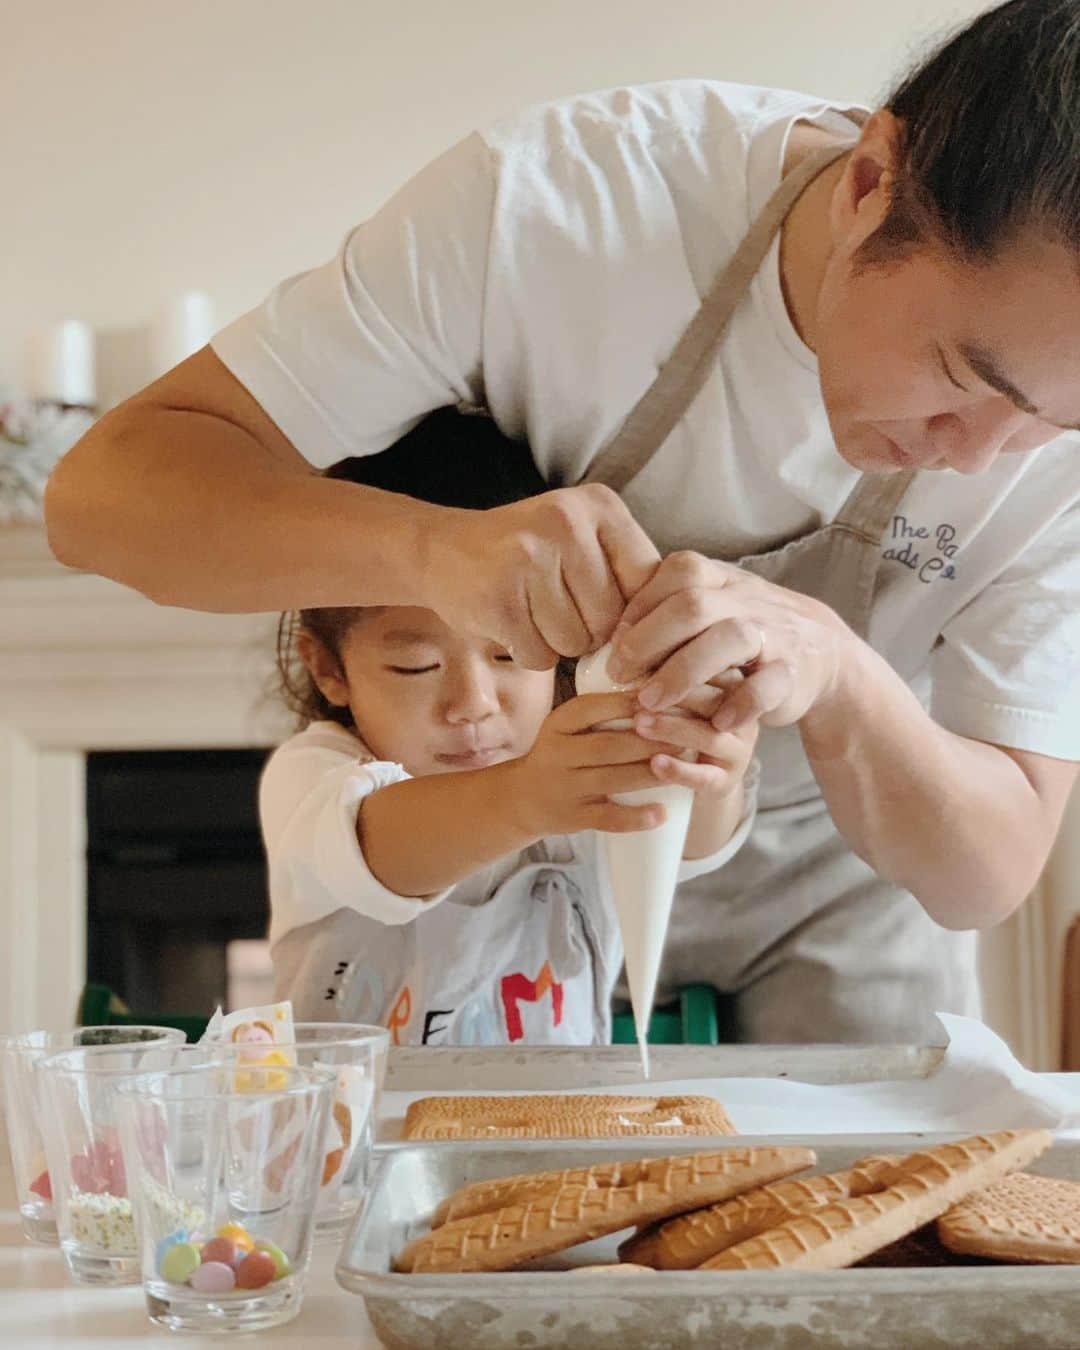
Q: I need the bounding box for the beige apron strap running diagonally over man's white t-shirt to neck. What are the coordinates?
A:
[582,143,852,491]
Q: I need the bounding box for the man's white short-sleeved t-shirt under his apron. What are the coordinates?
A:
[213,80,1080,759]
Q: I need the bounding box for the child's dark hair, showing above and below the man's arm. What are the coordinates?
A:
[277,408,566,726]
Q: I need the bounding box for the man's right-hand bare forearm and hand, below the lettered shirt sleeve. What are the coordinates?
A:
[609,554,1077,929]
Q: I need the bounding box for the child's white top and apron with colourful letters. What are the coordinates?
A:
[259,722,756,1045]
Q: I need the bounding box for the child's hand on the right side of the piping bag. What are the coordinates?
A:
[633,689,759,798]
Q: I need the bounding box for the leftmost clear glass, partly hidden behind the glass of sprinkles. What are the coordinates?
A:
[0,1026,184,1246]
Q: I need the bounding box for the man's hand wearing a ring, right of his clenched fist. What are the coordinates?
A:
[609,552,855,730]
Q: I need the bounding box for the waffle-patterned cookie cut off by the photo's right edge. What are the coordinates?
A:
[937,1172,1080,1265]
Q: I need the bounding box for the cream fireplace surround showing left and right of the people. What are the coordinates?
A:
[0,527,1064,1069]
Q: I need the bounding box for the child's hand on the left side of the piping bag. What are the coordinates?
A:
[502,691,688,837]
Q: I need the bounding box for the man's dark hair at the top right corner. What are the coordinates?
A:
[856,0,1080,266]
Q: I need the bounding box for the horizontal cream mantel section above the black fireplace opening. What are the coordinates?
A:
[0,528,284,751]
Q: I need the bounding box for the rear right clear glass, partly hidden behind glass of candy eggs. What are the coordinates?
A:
[208,1022,390,1242]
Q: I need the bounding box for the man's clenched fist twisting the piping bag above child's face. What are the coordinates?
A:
[421,483,660,670]
